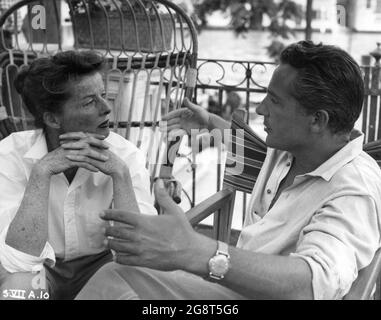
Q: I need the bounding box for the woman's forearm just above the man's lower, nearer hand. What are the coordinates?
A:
[112,169,140,213]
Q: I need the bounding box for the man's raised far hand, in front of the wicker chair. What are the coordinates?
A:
[160,98,210,140]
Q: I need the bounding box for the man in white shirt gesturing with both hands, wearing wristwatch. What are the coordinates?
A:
[78,41,381,299]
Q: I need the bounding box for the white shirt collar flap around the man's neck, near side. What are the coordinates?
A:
[294,130,364,181]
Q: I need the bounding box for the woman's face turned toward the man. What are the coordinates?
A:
[58,72,111,137]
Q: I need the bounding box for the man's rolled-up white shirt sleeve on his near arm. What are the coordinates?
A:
[291,196,380,300]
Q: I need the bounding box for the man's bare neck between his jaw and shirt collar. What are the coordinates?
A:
[290,135,350,175]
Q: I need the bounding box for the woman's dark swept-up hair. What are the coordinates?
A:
[14,51,104,128]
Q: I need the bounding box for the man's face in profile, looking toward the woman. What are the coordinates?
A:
[257,64,311,152]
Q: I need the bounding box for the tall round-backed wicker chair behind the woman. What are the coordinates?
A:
[0,0,197,190]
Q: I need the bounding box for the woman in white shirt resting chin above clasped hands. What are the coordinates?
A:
[0,51,156,299]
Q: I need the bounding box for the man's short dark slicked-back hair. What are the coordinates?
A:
[280,41,364,133]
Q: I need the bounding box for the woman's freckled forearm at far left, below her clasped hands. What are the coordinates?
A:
[5,167,51,256]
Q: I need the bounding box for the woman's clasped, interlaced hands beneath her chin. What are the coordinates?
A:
[60,132,128,177]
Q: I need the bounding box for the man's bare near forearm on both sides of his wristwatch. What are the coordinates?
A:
[186,238,313,300]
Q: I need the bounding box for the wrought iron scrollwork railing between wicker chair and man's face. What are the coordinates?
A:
[175,59,276,228]
